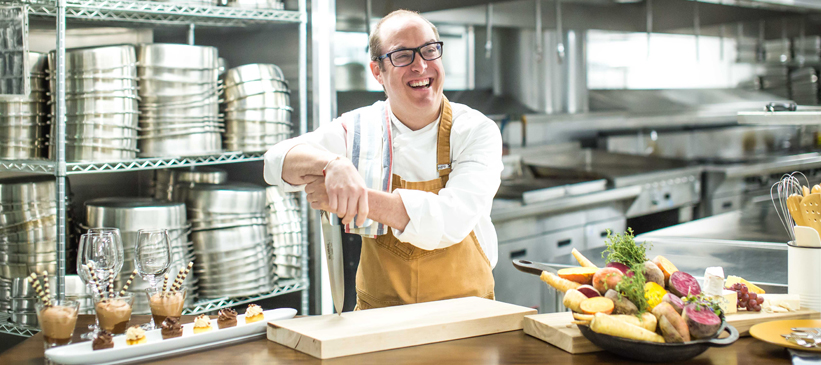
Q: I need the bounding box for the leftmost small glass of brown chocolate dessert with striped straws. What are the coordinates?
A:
[35,298,80,349]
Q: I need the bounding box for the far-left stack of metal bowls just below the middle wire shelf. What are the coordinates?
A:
[0,175,57,280]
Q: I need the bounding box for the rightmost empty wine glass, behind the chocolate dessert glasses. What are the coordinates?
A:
[134,229,171,329]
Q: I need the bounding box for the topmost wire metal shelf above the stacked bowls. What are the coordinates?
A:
[0,0,305,27]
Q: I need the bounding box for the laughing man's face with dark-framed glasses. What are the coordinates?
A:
[371,16,445,116]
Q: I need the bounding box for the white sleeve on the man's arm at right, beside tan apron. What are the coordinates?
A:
[393,120,503,250]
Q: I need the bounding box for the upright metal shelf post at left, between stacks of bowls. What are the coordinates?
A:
[52,0,67,299]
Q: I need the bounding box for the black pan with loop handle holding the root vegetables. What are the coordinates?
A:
[579,321,738,363]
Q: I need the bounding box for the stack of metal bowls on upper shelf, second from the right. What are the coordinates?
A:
[137,44,224,157]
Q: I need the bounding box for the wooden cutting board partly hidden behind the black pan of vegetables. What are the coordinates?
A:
[524,309,821,354]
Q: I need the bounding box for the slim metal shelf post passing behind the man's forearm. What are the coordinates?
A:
[298,0,310,315]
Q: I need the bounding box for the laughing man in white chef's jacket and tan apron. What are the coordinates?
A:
[264,10,502,309]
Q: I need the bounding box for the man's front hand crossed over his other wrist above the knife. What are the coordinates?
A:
[312,159,368,226]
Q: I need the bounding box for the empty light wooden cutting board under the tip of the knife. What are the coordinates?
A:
[268,297,536,359]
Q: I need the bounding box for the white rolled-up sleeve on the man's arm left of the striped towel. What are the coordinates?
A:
[263,119,345,193]
